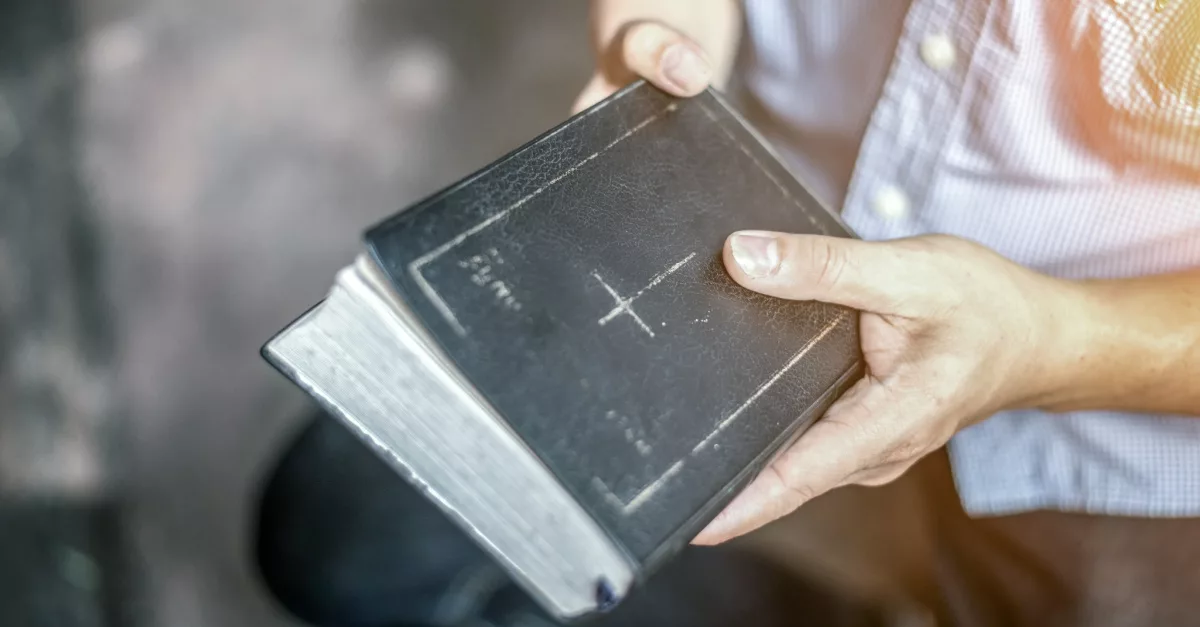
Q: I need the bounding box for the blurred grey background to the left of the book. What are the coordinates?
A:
[0,0,908,627]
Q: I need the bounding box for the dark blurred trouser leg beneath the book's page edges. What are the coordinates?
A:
[258,417,889,627]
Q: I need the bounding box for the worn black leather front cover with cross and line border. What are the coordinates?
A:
[366,83,862,569]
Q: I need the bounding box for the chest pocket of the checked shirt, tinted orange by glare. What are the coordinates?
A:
[1055,0,1200,172]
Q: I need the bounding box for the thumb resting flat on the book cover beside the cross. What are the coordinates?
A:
[724,231,941,315]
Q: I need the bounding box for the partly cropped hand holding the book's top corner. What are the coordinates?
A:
[572,0,740,113]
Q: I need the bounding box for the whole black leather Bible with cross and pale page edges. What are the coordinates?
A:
[263,83,862,620]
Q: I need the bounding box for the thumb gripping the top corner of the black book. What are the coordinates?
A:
[610,22,713,97]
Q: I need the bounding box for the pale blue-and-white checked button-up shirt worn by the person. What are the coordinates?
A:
[730,0,1200,516]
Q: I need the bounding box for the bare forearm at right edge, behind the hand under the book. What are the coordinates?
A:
[1038,271,1200,417]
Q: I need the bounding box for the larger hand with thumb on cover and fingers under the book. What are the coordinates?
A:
[694,232,1076,544]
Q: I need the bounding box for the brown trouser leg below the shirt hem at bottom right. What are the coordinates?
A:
[918,453,1200,627]
